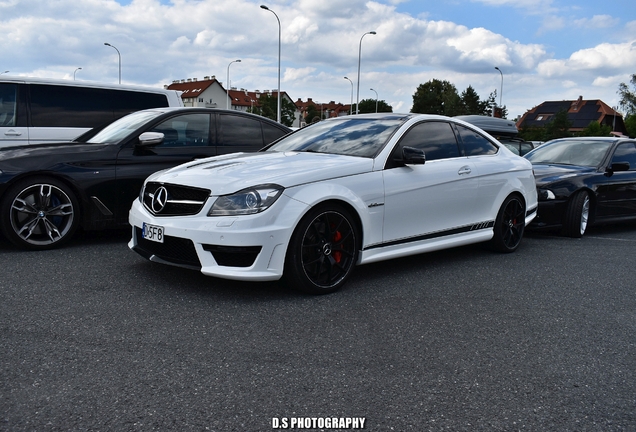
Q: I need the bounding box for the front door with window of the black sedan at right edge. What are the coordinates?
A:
[596,142,636,219]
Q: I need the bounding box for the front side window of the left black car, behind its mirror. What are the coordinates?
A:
[151,114,210,147]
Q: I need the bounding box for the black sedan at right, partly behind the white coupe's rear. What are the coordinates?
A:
[525,137,636,237]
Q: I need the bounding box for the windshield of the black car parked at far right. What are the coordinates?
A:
[525,140,612,167]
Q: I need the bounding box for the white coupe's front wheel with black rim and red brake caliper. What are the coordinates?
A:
[284,205,360,294]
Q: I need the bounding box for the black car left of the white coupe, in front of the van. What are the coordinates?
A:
[0,108,291,250]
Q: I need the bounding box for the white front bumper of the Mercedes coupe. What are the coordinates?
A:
[128,195,307,281]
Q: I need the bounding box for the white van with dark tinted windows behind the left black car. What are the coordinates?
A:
[0,75,183,148]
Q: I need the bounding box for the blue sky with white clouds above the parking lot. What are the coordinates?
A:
[0,0,636,117]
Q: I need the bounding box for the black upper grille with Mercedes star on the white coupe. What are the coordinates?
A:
[143,182,210,216]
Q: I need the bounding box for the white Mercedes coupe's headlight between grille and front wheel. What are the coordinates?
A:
[208,184,284,216]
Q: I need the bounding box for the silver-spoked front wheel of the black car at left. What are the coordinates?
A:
[0,177,80,250]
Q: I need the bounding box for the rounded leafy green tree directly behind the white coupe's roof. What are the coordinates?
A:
[411,79,462,116]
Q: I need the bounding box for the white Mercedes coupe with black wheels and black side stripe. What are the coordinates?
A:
[129,113,537,294]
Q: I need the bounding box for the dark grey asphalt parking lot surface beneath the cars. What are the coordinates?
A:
[0,223,636,431]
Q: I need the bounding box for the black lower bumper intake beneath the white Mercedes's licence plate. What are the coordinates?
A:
[135,227,201,269]
